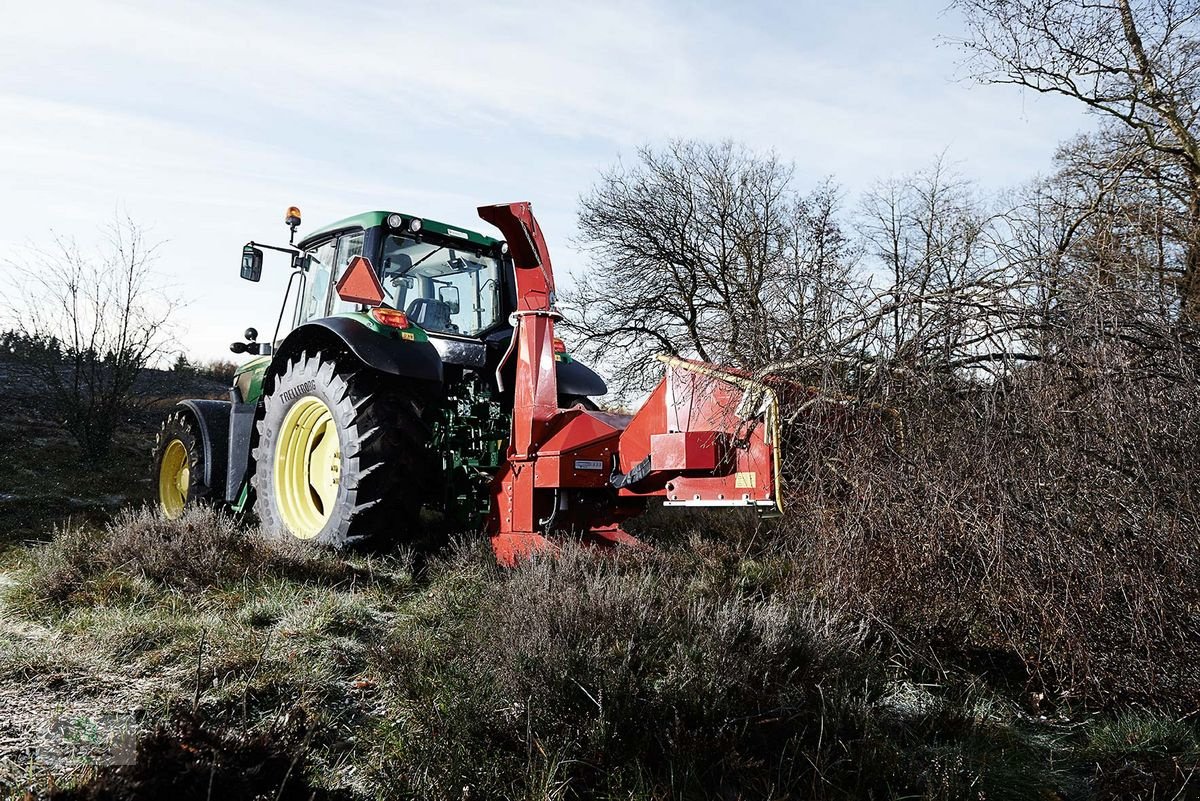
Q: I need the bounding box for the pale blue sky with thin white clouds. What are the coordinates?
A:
[0,0,1088,360]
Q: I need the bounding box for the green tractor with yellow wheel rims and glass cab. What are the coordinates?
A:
[155,207,607,547]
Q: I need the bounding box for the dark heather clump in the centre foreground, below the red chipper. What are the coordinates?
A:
[374,552,883,796]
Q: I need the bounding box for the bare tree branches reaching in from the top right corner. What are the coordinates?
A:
[954,0,1200,319]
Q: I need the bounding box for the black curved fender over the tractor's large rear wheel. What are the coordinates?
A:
[270,317,442,384]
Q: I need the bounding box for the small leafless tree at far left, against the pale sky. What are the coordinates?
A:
[7,218,176,457]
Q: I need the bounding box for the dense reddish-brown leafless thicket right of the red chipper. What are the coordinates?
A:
[770,330,1200,713]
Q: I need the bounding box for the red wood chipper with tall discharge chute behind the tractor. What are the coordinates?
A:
[479,203,781,565]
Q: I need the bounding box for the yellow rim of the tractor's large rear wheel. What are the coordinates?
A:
[274,395,342,540]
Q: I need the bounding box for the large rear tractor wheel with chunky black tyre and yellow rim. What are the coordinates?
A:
[253,353,432,548]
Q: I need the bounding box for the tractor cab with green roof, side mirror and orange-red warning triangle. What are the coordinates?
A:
[232,206,607,393]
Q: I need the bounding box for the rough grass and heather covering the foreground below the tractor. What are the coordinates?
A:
[0,511,1200,800]
